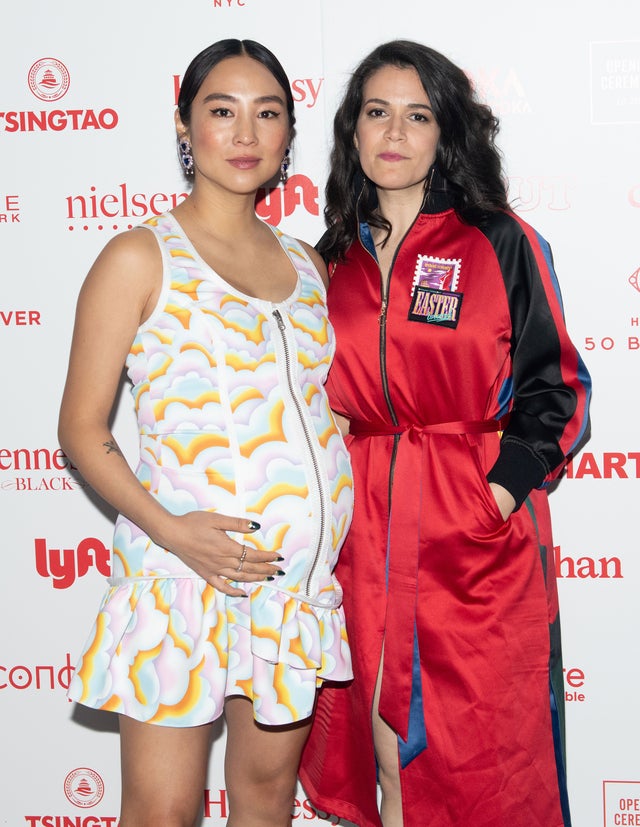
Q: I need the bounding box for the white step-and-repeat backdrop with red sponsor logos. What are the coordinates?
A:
[0,0,640,827]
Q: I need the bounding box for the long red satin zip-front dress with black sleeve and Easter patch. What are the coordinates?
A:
[300,199,590,827]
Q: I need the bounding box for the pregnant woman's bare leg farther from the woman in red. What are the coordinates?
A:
[120,715,212,827]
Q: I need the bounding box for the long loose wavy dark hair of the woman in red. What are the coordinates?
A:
[318,40,508,261]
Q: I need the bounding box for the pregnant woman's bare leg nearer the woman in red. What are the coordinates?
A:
[225,697,311,827]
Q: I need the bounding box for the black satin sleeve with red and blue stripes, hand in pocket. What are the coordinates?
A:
[483,214,577,509]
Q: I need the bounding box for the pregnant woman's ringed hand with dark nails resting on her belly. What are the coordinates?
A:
[154,511,282,597]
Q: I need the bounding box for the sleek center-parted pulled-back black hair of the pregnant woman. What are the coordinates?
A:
[178,38,296,133]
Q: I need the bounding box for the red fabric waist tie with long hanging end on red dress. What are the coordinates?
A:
[349,415,508,767]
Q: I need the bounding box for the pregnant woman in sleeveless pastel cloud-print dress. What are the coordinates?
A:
[59,40,352,827]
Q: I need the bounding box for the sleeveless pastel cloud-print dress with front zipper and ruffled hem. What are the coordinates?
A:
[69,213,353,726]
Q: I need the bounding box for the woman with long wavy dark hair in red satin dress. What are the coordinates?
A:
[301,41,590,827]
